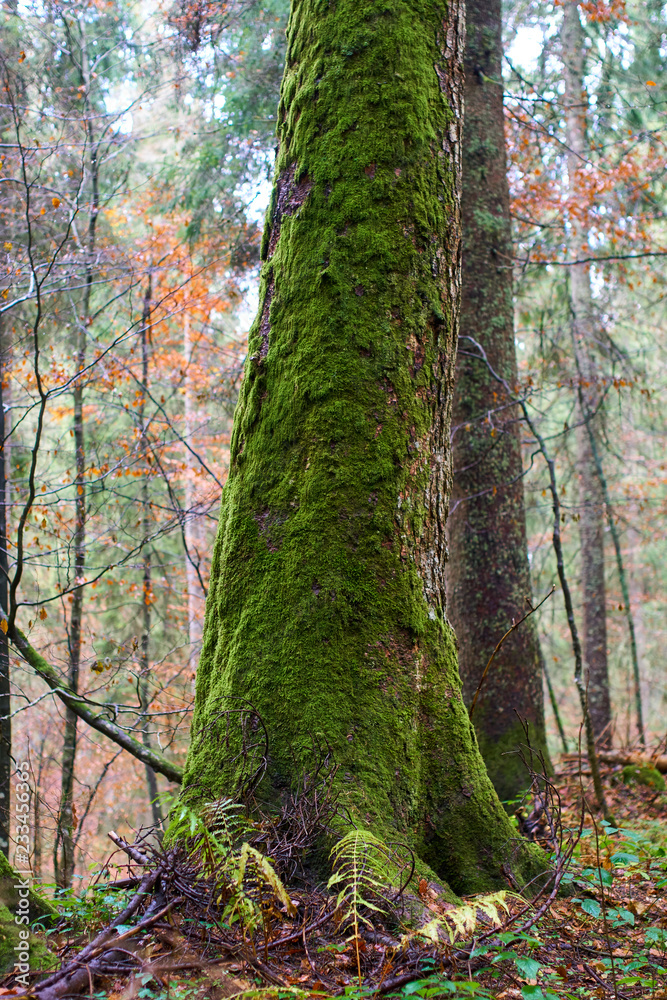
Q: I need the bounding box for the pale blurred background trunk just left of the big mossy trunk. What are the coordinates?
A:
[183,312,205,677]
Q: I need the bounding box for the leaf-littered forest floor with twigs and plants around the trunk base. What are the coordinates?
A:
[0,758,667,1000]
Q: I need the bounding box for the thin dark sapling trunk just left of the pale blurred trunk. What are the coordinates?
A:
[139,274,163,831]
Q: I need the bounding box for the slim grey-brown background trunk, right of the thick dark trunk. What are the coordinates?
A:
[561,3,611,746]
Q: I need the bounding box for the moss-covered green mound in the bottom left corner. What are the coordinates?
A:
[0,854,58,972]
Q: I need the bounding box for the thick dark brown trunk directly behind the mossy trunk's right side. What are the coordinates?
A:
[446,0,549,799]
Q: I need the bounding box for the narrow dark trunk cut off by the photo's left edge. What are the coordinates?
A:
[0,317,14,857]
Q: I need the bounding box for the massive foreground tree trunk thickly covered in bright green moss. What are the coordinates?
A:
[184,0,544,891]
